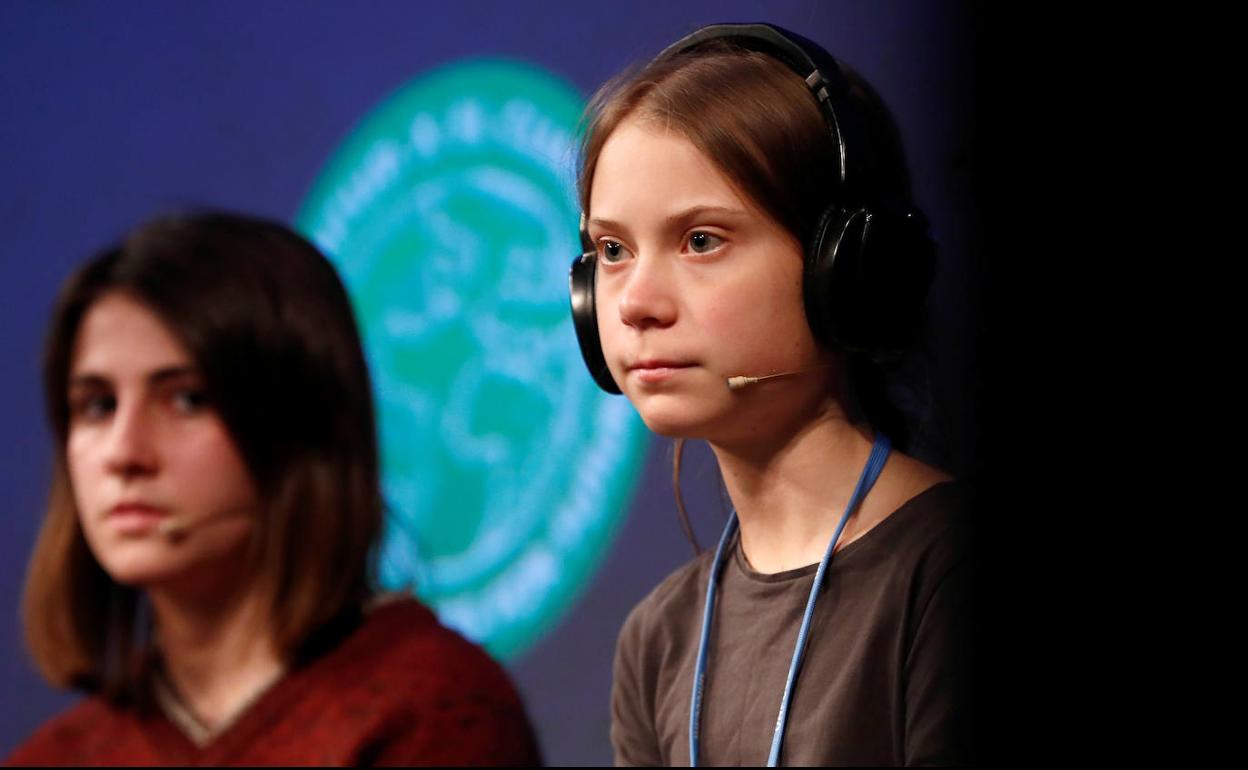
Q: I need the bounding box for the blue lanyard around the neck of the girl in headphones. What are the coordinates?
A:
[689,433,890,768]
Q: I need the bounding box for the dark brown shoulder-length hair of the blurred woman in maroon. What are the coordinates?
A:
[22,212,382,699]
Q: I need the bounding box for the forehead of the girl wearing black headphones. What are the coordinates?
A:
[589,117,758,220]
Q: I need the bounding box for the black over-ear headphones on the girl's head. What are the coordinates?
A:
[569,24,936,393]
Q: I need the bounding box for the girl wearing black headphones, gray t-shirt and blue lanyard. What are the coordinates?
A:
[570,24,973,765]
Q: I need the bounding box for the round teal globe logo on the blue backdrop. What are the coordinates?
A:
[297,60,648,660]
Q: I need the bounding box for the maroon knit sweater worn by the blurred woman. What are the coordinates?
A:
[6,599,540,765]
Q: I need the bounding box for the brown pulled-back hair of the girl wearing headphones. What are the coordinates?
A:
[578,41,910,553]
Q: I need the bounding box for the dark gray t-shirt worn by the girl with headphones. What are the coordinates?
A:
[612,482,973,766]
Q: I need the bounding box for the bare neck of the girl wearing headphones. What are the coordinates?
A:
[711,399,875,573]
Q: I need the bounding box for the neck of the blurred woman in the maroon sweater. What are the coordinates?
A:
[149,582,285,729]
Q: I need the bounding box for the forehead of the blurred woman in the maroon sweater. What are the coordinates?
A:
[70,293,191,377]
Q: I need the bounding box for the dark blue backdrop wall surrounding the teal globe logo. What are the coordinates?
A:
[0,0,1003,764]
